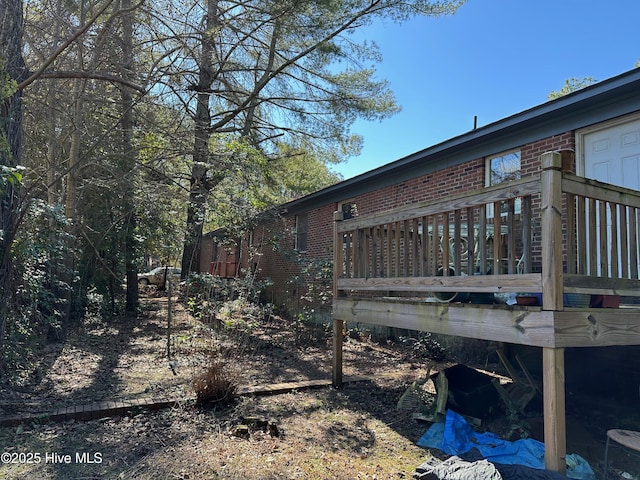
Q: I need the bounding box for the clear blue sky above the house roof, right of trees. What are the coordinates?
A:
[332,0,640,179]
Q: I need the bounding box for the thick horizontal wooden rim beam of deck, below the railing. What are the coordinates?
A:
[333,297,640,348]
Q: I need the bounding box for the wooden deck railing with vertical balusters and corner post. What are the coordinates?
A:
[334,154,640,306]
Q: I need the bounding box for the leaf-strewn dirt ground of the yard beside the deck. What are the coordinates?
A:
[0,295,640,479]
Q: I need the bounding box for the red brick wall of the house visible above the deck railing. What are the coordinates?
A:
[226,132,575,313]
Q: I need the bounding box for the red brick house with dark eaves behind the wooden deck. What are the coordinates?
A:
[214,70,640,313]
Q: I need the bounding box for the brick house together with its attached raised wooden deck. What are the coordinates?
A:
[204,69,640,471]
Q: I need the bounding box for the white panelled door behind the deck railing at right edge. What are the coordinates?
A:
[578,115,640,276]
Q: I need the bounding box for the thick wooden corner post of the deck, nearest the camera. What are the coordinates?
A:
[540,152,567,474]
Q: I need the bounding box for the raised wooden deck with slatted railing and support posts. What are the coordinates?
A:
[333,152,640,472]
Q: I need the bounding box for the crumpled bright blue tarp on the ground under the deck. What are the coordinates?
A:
[418,410,595,480]
